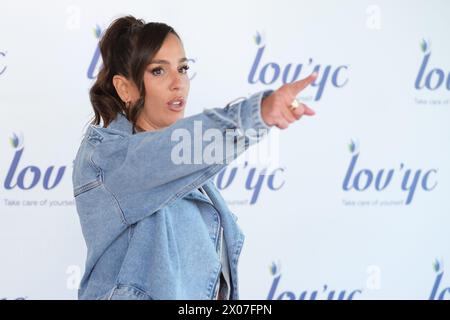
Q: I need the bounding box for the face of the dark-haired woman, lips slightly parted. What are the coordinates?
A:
[137,33,189,131]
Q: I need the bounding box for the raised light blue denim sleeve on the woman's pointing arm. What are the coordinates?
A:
[87,90,273,224]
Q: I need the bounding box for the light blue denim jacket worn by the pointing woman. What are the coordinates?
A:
[72,90,272,300]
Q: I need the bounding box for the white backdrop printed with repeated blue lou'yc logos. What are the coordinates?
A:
[0,0,450,299]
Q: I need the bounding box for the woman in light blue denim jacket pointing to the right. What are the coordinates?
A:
[72,16,316,299]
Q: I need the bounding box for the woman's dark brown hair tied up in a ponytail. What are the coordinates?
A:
[89,16,181,131]
